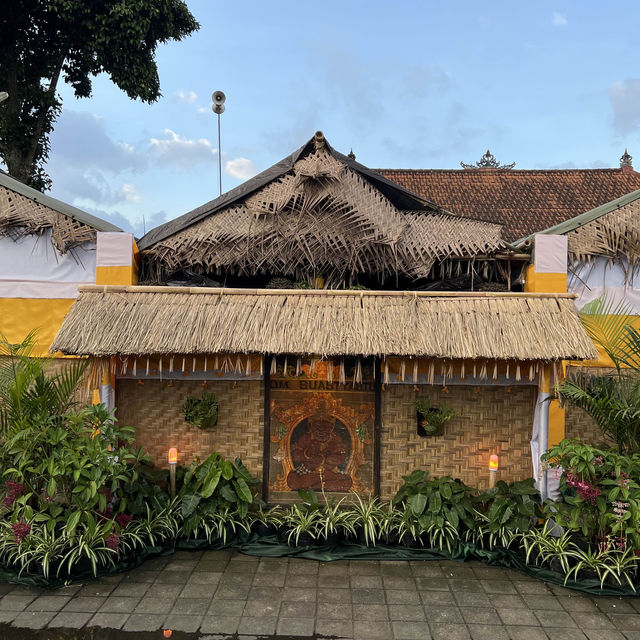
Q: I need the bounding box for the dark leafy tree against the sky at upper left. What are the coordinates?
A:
[0,0,199,189]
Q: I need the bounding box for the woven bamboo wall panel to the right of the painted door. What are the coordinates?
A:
[380,385,537,499]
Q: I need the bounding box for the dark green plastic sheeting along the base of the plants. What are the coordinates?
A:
[0,534,638,596]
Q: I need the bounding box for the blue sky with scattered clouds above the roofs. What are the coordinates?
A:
[43,0,640,235]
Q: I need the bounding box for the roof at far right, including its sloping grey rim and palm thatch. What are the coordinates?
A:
[518,190,640,263]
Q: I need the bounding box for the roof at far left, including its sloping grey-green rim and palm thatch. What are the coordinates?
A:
[0,171,122,253]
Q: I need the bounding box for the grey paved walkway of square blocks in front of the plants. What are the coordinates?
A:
[0,551,640,640]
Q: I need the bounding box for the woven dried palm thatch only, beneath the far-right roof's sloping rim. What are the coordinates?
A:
[567,199,640,264]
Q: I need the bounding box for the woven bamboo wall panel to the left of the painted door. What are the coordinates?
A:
[116,380,264,479]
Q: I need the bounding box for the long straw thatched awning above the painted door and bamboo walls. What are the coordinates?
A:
[51,285,596,361]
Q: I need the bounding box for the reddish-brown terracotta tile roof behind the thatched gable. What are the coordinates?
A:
[377,167,640,241]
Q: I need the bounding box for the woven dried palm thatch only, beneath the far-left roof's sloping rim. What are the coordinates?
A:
[0,186,96,254]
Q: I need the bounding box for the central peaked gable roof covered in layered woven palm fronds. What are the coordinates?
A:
[139,132,501,285]
